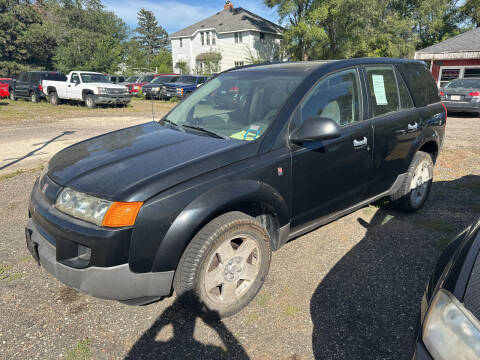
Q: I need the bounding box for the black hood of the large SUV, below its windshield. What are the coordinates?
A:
[48,122,251,201]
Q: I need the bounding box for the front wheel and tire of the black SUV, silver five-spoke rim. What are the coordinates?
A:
[173,211,271,318]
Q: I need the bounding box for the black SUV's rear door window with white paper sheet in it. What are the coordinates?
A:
[366,65,399,117]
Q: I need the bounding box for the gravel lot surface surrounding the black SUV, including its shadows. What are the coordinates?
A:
[0,111,480,360]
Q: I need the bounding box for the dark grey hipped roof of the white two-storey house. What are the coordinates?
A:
[170,7,284,38]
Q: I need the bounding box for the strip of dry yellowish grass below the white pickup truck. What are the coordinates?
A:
[0,98,175,124]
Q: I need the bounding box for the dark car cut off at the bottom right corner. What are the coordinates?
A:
[413,219,480,360]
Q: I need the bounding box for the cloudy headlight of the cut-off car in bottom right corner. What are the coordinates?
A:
[423,289,480,360]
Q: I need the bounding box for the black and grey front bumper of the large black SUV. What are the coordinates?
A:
[26,176,174,305]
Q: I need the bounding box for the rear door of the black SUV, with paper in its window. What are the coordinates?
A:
[364,64,420,197]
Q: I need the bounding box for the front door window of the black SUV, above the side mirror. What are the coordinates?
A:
[302,69,361,126]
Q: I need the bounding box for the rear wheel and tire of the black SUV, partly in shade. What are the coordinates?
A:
[391,151,433,213]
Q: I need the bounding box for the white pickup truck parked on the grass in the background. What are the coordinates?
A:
[42,71,130,108]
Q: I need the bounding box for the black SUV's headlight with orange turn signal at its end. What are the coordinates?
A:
[55,188,143,227]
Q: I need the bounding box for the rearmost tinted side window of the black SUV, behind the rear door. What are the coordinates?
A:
[397,63,440,107]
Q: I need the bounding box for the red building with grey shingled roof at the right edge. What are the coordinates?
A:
[415,28,480,87]
